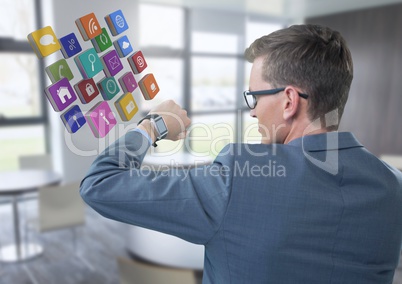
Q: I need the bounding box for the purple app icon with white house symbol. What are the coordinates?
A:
[45,78,77,111]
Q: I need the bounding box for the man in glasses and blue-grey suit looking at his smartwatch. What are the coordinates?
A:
[81,25,402,284]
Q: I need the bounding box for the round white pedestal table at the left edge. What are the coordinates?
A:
[0,170,61,262]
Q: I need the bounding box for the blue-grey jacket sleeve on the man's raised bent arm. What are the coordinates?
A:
[80,131,233,244]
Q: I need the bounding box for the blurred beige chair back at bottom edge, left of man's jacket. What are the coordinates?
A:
[117,257,197,284]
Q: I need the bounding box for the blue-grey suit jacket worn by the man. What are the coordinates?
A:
[81,131,402,284]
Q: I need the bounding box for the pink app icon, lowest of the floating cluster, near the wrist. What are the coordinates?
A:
[85,101,117,138]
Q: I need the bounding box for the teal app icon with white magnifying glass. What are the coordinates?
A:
[74,48,103,79]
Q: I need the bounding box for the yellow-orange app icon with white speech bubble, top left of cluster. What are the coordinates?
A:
[28,26,61,58]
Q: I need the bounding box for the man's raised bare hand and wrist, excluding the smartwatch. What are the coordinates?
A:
[139,100,191,141]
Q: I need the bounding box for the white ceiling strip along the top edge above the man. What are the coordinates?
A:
[141,0,402,20]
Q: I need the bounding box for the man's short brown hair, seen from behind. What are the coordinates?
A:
[245,25,353,125]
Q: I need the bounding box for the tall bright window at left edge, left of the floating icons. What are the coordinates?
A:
[0,0,47,170]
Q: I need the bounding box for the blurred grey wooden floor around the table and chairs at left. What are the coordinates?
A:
[0,202,402,284]
